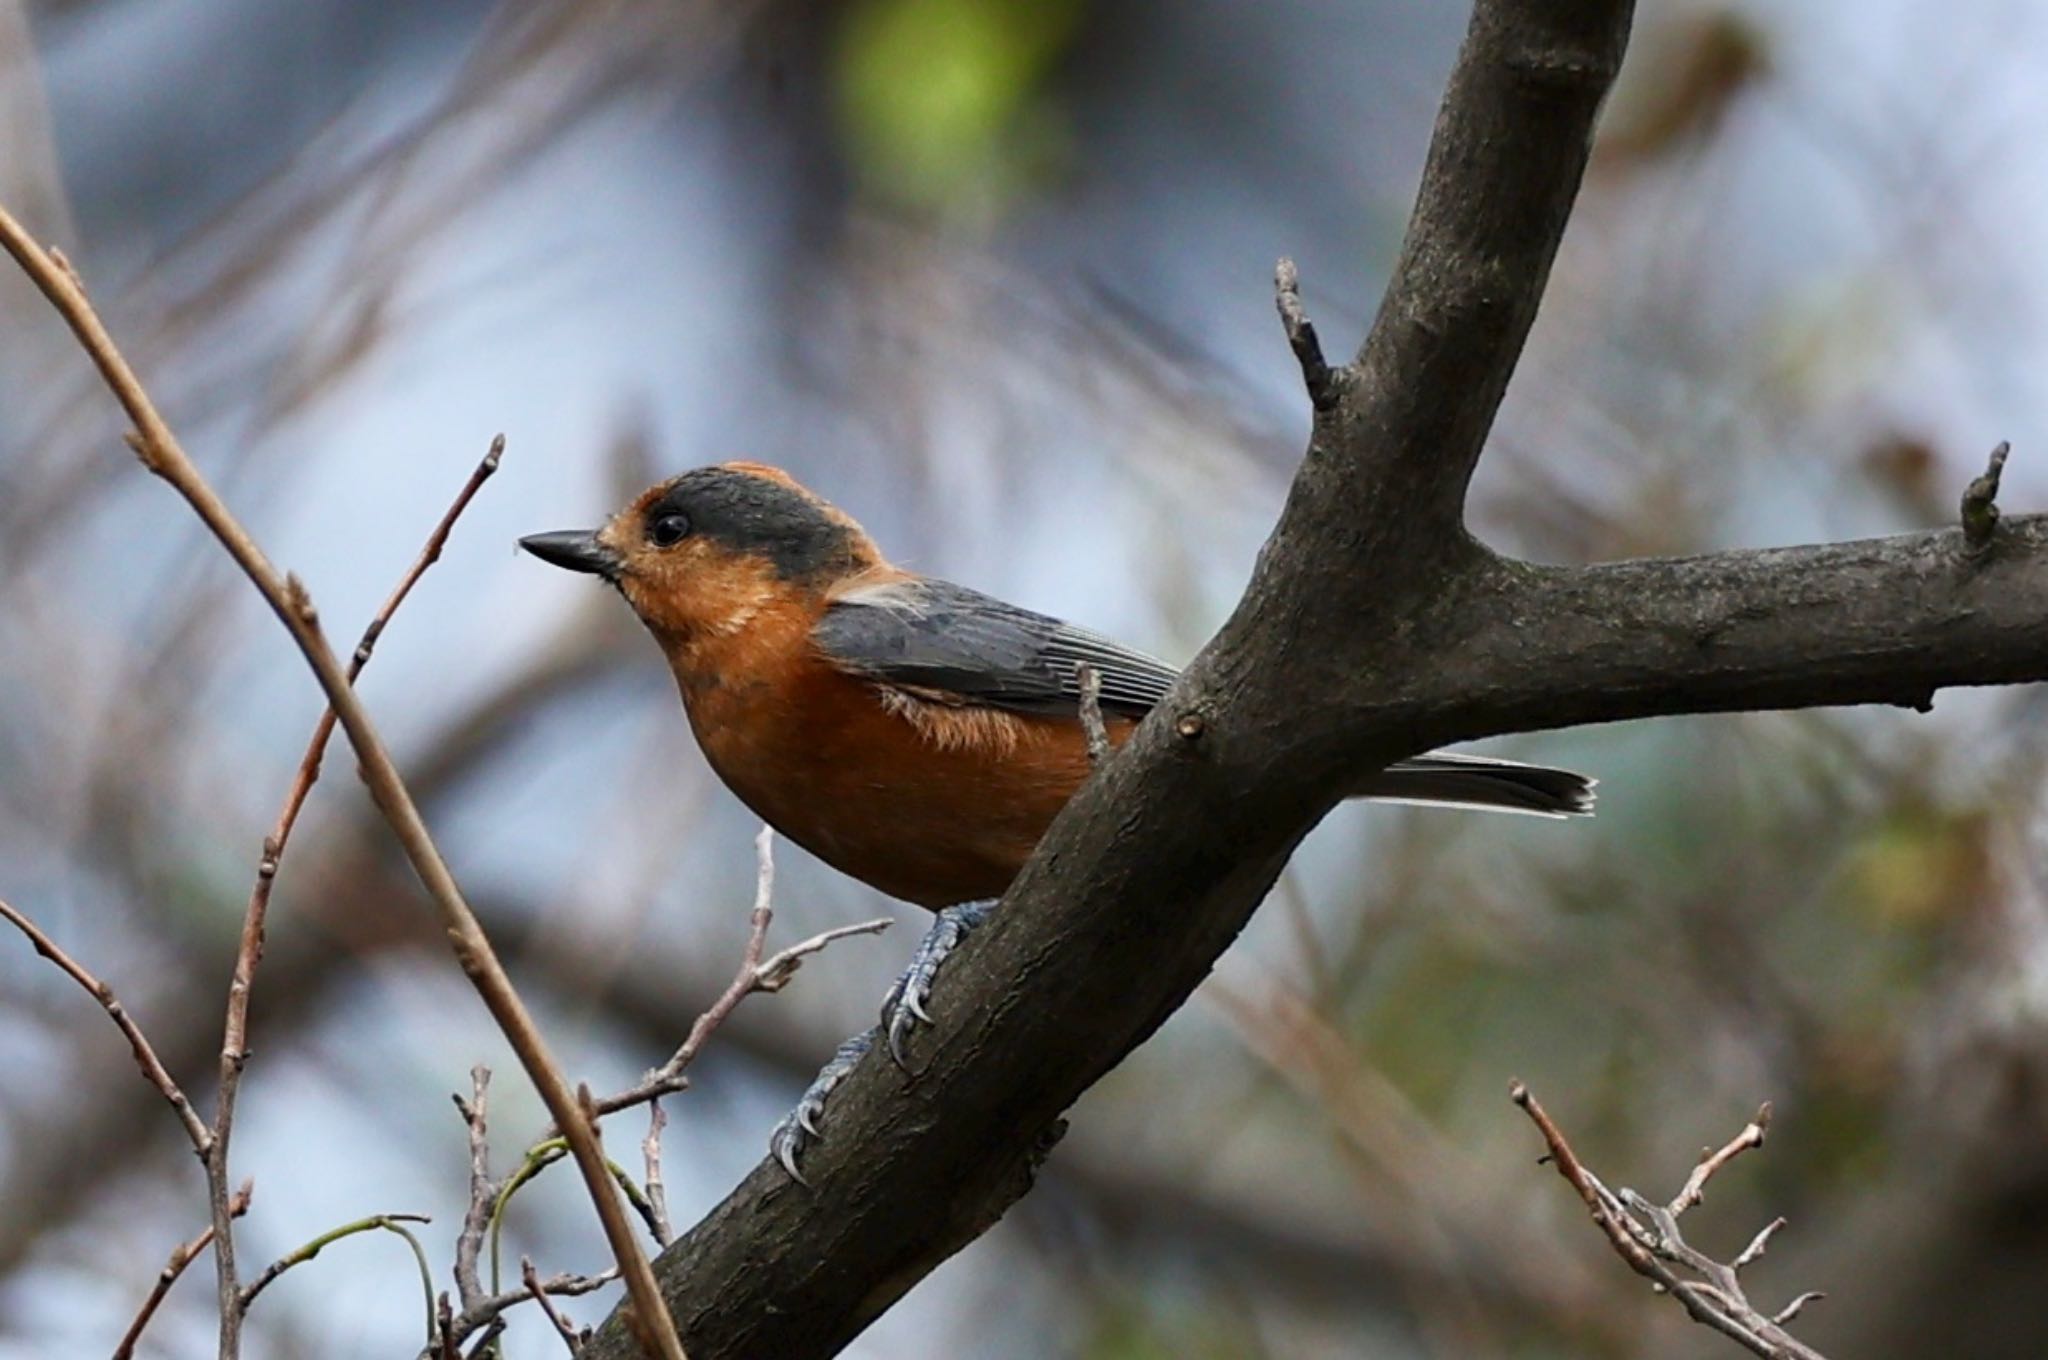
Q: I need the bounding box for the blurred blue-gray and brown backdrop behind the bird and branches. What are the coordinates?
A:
[0,0,2048,1360]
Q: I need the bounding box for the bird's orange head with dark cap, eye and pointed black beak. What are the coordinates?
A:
[520,463,881,641]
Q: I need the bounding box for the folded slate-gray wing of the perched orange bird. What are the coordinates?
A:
[811,580,1180,717]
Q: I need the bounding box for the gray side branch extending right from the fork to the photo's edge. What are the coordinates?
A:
[1425,516,2048,741]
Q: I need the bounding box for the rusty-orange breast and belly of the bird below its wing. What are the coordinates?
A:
[672,619,1133,909]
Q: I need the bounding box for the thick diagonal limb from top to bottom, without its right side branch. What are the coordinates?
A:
[588,0,1630,1360]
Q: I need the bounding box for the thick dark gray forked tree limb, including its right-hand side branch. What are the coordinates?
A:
[590,0,2048,1360]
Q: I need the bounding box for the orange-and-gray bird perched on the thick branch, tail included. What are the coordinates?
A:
[520,461,1595,1180]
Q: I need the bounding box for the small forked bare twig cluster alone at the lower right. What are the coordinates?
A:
[1507,1081,1825,1360]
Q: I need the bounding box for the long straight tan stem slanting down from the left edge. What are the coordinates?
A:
[0,199,684,1360]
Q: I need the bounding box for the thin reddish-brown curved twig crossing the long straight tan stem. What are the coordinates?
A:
[207,434,506,1351]
